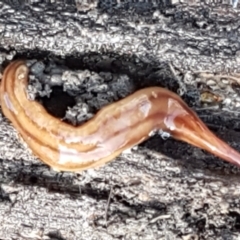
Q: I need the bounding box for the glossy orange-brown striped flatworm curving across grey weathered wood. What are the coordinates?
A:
[0,61,240,172]
